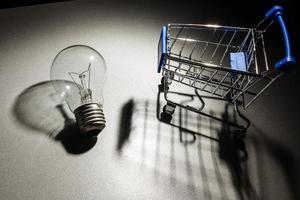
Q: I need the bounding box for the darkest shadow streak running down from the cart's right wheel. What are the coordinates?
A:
[217,104,259,200]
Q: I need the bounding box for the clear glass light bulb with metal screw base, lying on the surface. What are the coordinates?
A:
[50,45,106,136]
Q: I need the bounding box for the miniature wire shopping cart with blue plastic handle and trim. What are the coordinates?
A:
[158,6,295,138]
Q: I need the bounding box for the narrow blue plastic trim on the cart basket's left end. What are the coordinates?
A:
[157,26,168,73]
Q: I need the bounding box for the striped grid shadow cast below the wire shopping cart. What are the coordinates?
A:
[116,89,259,200]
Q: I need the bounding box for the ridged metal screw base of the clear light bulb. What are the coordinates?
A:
[74,103,106,136]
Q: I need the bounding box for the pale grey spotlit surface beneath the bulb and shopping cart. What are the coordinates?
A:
[0,1,300,200]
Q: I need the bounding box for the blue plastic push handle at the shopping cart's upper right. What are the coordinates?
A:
[265,6,296,70]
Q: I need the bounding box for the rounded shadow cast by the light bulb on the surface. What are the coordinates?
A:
[12,80,97,154]
